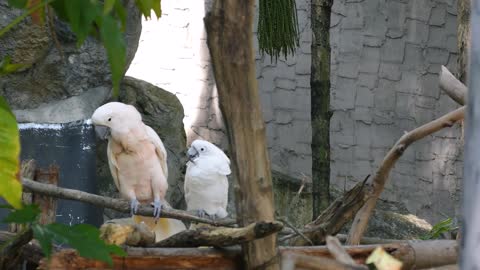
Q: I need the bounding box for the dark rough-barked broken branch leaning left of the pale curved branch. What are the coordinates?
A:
[290,176,373,246]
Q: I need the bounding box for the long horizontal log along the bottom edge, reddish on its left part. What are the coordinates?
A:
[40,240,458,270]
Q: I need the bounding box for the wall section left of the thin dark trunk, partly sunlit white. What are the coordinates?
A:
[127,0,312,177]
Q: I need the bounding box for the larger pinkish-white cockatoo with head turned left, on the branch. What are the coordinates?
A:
[92,102,185,241]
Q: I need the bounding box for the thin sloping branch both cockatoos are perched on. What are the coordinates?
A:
[22,178,236,226]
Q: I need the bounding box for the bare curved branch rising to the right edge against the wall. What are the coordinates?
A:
[347,106,465,245]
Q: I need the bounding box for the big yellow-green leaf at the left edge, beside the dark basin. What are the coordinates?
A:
[0,96,22,209]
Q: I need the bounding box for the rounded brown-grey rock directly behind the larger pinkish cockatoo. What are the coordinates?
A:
[97,77,187,218]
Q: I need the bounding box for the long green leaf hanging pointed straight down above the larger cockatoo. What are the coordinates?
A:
[99,16,127,96]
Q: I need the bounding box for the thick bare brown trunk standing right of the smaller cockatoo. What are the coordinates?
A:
[205,0,279,269]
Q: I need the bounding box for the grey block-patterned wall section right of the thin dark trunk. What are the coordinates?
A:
[330,0,463,222]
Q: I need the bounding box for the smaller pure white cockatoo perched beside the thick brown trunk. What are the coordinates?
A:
[184,140,231,218]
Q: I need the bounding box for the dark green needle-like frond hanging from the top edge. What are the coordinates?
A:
[258,0,299,60]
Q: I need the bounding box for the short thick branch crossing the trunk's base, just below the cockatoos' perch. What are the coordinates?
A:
[154,221,283,247]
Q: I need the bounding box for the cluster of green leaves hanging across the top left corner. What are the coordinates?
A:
[0,0,162,96]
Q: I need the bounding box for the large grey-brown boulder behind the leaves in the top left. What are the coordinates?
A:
[0,0,142,112]
